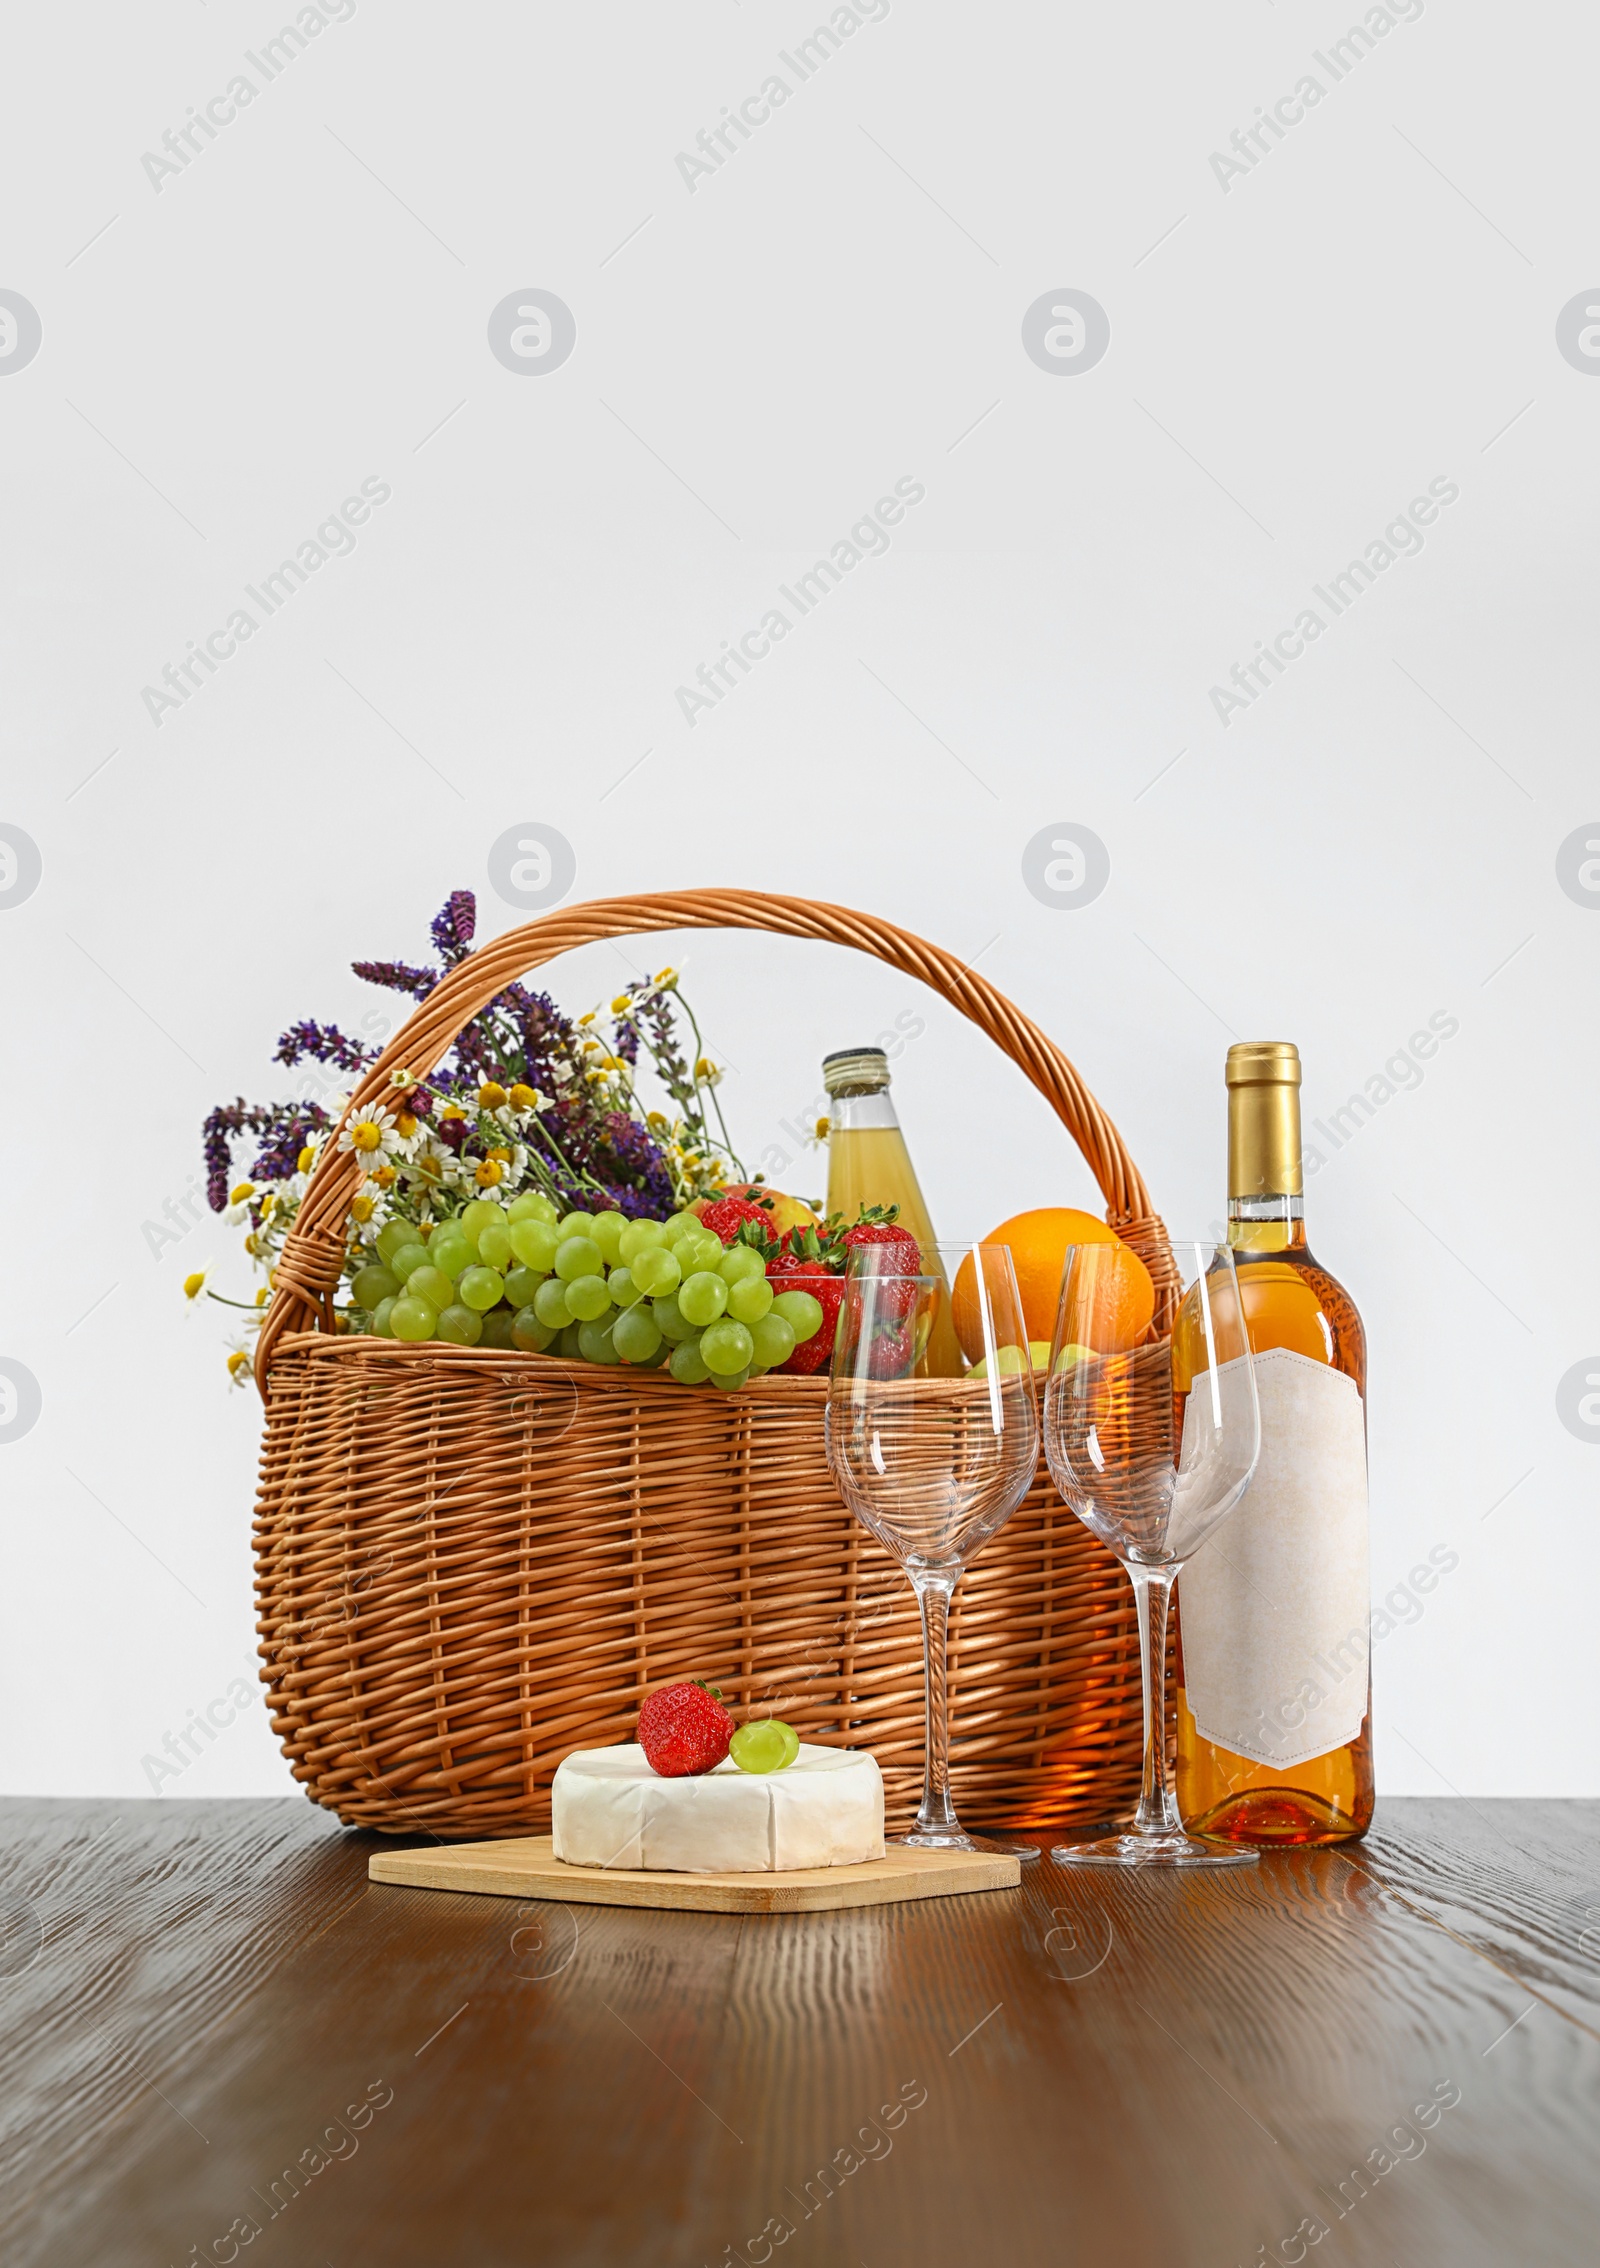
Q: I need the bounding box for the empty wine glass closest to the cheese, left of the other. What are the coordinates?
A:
[826,1245,1039,1860]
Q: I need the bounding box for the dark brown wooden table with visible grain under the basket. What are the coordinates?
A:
[0,1801,1600,2268]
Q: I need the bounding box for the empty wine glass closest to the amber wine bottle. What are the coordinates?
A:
[1044,1243,1262,1867]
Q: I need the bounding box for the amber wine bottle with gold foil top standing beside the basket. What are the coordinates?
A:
[1176,1041,1373,1846]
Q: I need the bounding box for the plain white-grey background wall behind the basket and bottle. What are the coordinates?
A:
[0,0,1600,1796]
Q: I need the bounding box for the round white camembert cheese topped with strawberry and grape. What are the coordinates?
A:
[551,1742,883,1873]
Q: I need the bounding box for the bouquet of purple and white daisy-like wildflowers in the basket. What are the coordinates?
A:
[196,889,744,1383]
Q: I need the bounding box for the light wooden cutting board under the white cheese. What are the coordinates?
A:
[368,1835,1021,1914]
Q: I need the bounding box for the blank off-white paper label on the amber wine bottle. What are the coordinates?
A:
[1178,1347,1371,1767]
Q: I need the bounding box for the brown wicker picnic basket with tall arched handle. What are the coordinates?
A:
[254,889,1171,1837]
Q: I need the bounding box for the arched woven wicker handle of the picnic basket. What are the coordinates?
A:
[254,889,1171,1399]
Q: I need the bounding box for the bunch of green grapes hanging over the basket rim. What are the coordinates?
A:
[350,1193,822,1393]
